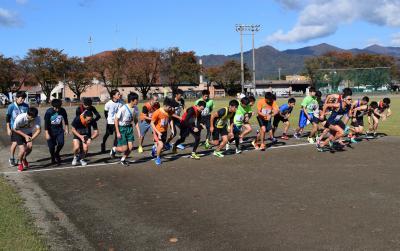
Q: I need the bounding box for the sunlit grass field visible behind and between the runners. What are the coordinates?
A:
[96,95,400,136]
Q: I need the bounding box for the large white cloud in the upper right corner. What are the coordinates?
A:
[267,0,400,43]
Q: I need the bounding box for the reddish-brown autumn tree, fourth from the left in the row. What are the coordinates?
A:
[87,48,128,94]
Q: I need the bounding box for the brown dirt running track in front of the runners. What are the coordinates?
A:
[1,106,400,250]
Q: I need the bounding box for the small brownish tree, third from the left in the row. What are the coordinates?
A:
[65,57,94,99]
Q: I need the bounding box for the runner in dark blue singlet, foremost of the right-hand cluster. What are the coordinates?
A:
[317,90,352,150]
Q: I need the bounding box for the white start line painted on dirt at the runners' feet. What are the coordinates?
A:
[1,143,315,175]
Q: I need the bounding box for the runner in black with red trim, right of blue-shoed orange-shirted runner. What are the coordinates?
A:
[172,101,206,160]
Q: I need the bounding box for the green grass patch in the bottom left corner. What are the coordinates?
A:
[0,177,48,250]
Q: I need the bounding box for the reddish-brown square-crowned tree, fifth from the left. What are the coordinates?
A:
[125,50,161,99]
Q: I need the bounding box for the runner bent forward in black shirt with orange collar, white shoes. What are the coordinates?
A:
[71,110,99,166]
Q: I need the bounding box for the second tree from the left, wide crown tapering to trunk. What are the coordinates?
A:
[24,48,67,103]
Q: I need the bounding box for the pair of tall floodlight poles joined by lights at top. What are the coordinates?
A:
[236,24,260,95]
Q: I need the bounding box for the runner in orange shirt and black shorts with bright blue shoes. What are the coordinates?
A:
[150,98,175,165]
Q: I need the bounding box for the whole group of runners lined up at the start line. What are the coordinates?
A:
[6,87,391,171]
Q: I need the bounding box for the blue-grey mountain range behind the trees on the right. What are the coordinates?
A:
[199,43,400,79]
